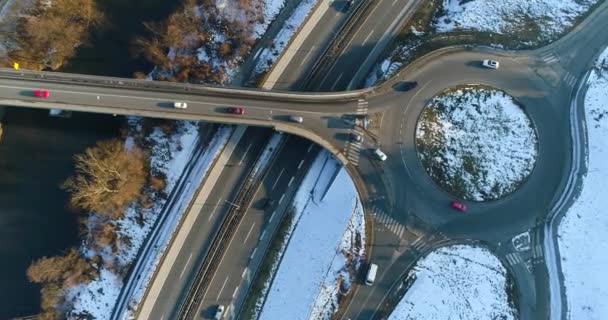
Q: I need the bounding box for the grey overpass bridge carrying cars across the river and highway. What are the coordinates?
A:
[0,68,371,165]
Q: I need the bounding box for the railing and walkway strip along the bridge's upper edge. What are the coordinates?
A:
[0,68,370,102]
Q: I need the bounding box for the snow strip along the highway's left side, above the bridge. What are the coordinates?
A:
[254,0,319,74]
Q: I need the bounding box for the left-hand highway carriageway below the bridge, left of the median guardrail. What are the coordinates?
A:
[144,127,271,319]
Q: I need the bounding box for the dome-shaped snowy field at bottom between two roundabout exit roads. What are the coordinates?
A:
[388,245,517,320]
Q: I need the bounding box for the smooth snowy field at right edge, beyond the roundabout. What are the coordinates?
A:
[558,50,608,320]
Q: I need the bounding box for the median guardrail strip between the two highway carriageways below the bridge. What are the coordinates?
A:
[178,134,285,320]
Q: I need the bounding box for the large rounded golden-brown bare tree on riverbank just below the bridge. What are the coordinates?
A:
[61,139,147,219]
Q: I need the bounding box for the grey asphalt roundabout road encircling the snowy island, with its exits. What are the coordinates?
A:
[343,4,608,319]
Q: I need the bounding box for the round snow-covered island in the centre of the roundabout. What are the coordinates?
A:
[416,86,537,201]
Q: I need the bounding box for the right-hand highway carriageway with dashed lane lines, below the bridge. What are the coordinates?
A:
[198,136,318,319]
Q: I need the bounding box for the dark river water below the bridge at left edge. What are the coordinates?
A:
[0,108,120,319]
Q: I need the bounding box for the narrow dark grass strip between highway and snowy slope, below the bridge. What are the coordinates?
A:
[239,208,294,320]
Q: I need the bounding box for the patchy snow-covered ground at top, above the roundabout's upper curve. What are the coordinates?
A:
[365,0,598,87]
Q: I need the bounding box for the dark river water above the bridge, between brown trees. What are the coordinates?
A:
[60,0,181,78]
